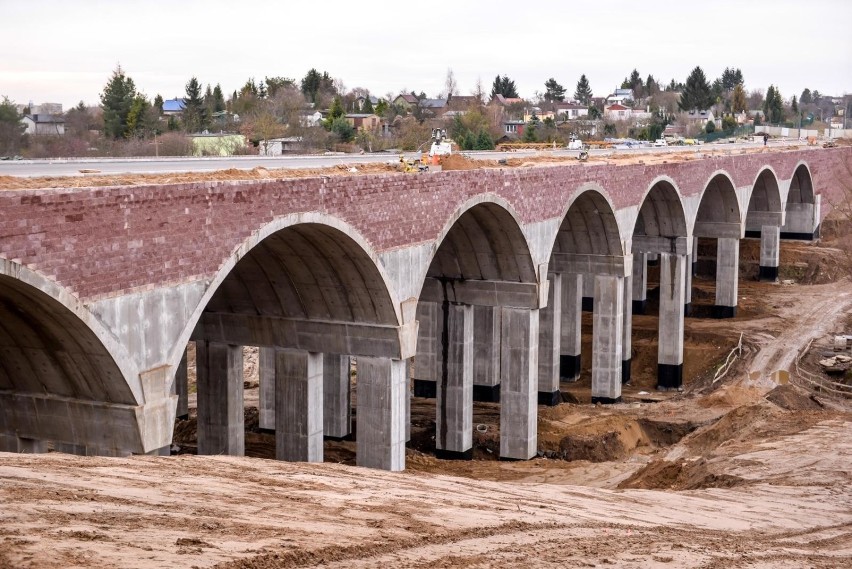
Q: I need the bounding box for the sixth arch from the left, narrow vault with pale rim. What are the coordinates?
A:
[692,170,744,239]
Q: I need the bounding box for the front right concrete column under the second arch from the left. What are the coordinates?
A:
[356,356,408,471]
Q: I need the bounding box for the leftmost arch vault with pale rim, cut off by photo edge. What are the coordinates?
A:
[0,258,145,405]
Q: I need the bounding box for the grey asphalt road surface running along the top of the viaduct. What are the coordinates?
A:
[0,143,792,177]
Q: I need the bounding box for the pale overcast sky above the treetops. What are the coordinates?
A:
[0,0,852,109]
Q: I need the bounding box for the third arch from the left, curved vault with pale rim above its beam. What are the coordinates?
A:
[426,194,538,282]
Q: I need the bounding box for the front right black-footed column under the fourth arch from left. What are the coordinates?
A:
[592,275,624,403]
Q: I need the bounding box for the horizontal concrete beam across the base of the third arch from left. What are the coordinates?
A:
[420,277,546,309]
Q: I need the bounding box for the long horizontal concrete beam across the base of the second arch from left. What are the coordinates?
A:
[192,312,417,359]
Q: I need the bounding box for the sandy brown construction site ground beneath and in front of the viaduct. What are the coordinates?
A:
[0,163,852,569]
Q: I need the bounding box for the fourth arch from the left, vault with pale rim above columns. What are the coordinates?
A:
[548,183,624,257]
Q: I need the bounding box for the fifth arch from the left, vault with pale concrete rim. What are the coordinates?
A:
[632,176,689,237]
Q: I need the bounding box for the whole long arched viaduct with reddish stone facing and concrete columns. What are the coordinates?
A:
[0,149,852,470]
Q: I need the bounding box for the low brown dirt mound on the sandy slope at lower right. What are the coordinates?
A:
[618,458,750,490]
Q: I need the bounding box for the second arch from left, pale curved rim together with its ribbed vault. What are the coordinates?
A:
[169,212,401,366]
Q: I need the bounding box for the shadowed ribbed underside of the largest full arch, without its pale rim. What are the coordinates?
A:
[205,223,397,325]
